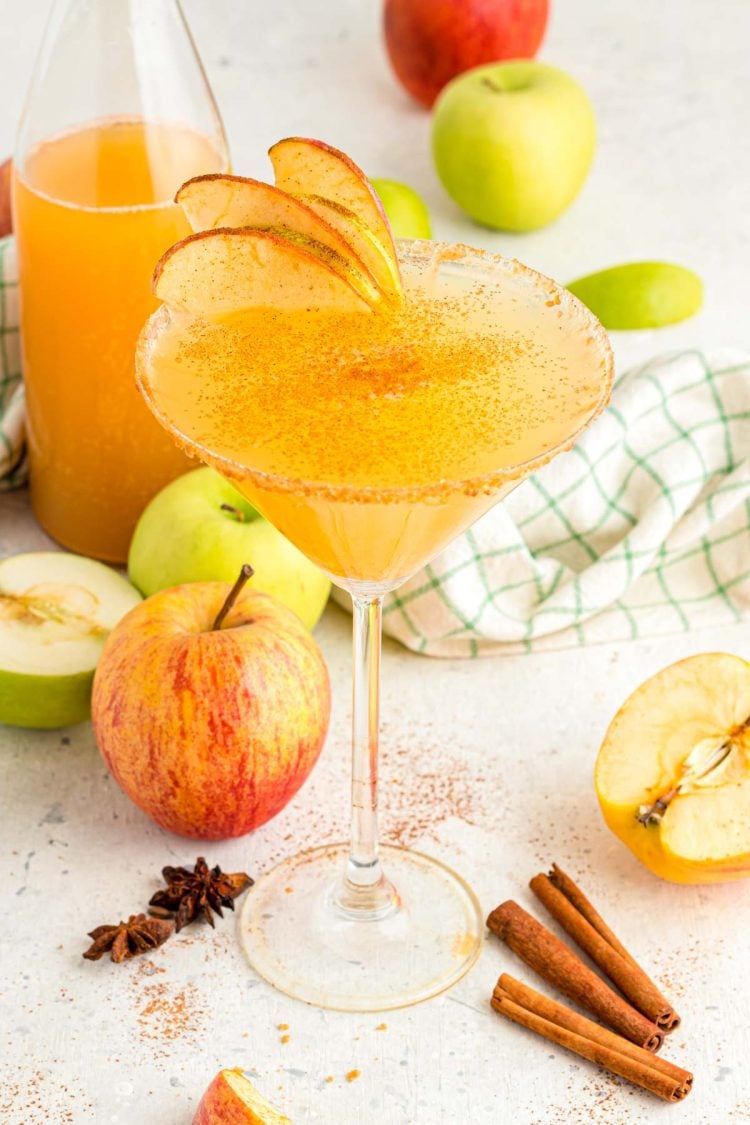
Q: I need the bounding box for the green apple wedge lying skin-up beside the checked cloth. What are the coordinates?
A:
[568,262,703,330]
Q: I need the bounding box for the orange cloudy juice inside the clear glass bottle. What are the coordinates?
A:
[15,118,224,561]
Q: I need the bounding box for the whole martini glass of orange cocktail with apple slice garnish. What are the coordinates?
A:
[137,138,612,1011]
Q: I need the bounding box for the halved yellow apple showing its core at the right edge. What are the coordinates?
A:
[595,653,750,883]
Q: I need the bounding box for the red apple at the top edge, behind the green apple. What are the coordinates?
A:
[383,0,549,107]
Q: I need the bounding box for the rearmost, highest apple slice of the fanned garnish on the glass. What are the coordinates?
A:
[269,137,401,296]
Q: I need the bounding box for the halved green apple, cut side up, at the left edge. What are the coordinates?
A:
[0,551,141,728]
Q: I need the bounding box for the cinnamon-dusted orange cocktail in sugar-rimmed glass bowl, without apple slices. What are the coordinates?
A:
[138,248,611,590]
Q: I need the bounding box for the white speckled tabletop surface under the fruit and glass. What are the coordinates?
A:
[0,0,750,1125]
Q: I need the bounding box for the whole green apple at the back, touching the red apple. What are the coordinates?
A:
[432,60,596,231]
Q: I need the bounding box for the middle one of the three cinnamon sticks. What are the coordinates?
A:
[487,900,665,1051]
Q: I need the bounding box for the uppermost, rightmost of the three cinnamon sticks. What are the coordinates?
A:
[528,864,680,1032]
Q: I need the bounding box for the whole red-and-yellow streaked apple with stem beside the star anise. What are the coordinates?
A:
[91,572,331,839]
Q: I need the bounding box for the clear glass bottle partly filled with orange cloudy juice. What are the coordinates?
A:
[13,0,227,563]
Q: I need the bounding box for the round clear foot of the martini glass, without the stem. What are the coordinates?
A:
[238,844,485,1011]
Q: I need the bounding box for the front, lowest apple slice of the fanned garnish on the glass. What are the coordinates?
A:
[153,227,371,318]
